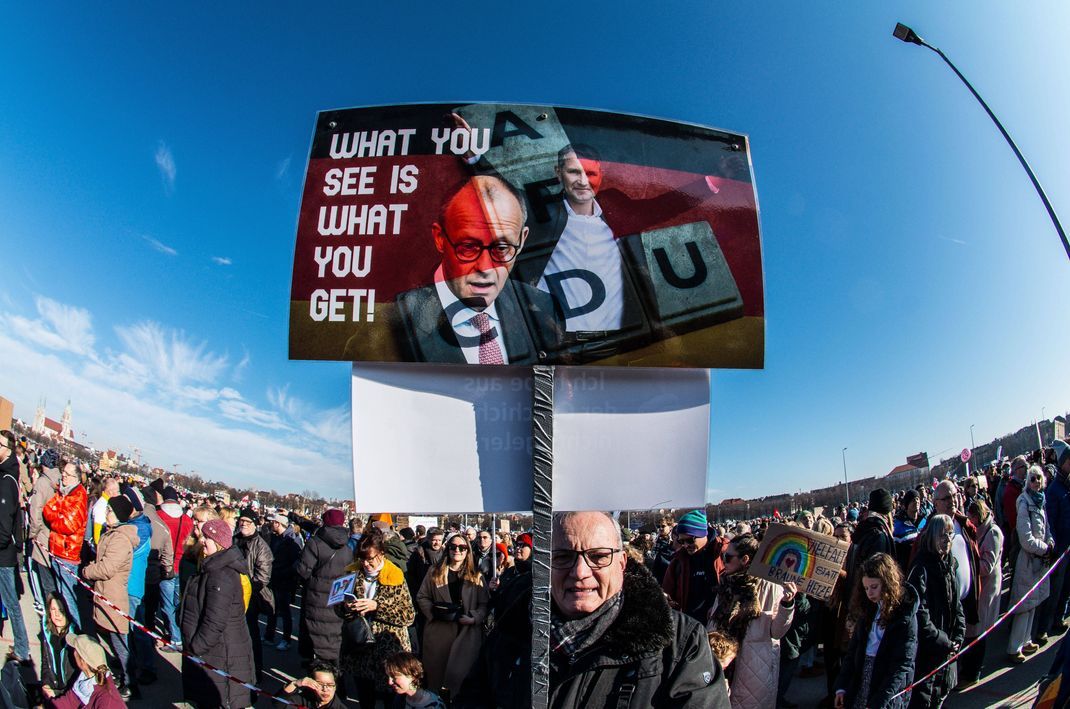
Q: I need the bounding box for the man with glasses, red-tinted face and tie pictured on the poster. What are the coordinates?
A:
[397,175,564,365]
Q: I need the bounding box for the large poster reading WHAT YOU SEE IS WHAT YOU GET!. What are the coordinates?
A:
[290,104,765,368]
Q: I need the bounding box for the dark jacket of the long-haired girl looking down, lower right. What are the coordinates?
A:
[836,584,918,709]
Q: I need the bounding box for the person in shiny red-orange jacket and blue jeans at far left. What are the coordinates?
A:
[41,459,89,632]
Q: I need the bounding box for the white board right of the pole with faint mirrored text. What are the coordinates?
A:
[553,367,709,510]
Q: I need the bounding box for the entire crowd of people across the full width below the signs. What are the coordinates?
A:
[0,423,1070,709]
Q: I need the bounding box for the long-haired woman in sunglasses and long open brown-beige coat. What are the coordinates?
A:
[416,534,488,696]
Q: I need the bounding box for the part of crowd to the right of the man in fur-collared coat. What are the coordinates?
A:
[629,441,1070,709]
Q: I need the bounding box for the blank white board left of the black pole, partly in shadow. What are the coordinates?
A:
[353,364,532,513]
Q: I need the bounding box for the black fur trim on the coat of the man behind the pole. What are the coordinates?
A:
[598,559,673,657]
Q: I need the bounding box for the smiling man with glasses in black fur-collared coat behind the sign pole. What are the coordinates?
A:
[550,512,730,709]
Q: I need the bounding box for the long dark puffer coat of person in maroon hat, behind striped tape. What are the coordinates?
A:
[182,546,254,707]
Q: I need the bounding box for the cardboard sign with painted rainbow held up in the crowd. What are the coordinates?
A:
[749,523,851,600]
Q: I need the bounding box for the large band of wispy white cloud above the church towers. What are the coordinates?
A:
[0,296,352,497]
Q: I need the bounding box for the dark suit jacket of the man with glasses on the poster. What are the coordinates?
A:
[397,279,565,365]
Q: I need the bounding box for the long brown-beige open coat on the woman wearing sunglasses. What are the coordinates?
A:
[416,569,488,696]
